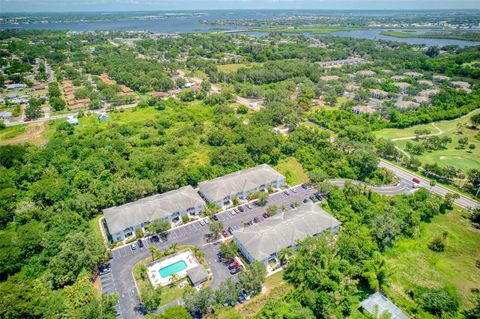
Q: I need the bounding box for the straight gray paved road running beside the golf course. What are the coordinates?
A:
[378,160,480,209]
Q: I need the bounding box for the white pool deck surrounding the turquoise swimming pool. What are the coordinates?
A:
[147,249,200,287]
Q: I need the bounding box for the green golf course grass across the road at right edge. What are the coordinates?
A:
[375,110,480,171]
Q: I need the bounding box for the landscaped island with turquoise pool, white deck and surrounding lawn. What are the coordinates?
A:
[132,245,212,310]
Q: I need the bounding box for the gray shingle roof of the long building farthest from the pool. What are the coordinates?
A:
[198,164,285,201]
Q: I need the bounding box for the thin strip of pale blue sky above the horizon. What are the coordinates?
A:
[0,0,480,14]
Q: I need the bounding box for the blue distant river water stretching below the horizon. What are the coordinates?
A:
[0,10,480,47]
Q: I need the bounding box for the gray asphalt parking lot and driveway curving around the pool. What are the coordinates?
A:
[101,186,316,319]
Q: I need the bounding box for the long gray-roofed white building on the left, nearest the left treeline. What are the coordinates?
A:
[103,185,205,242]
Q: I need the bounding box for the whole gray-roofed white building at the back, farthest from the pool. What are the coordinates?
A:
[198,164,285,207]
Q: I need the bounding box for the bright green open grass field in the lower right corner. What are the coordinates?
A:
[386,210,480,318]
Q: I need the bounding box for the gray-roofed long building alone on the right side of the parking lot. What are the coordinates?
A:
[233,203,340,265]
